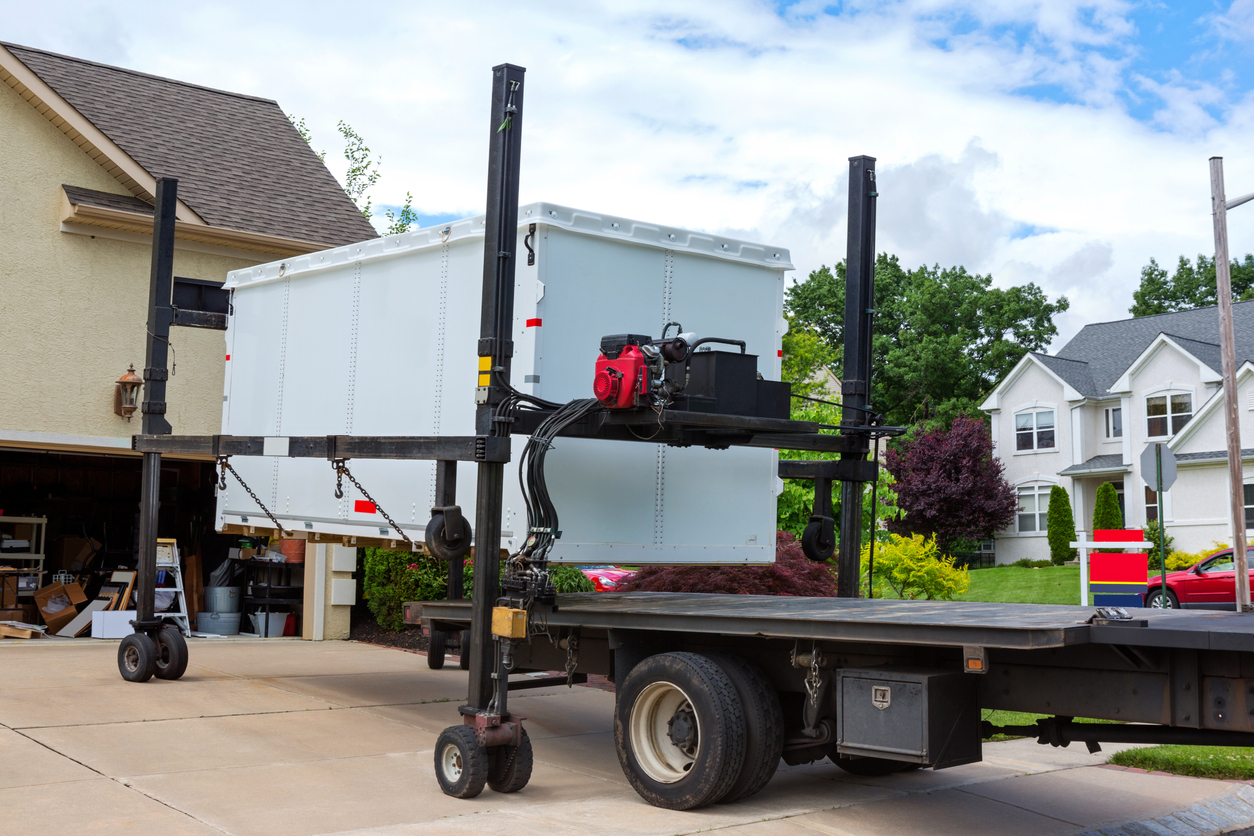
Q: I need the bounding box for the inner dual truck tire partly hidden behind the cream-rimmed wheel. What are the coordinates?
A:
[705,652,784,803]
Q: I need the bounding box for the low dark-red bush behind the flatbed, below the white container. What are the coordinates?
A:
[617,531,837,598]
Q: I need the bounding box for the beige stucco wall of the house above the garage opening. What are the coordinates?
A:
[0,85,257,449]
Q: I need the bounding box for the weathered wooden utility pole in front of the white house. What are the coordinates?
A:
[1203,157,1250,613]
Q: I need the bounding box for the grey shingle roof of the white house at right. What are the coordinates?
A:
[1050,301,1254,396]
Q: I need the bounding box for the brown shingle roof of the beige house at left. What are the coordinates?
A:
[4,44,377,246]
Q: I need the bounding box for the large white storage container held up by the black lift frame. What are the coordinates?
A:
[218,203,791,564]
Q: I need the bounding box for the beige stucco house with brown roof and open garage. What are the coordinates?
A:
[0,44,376,636]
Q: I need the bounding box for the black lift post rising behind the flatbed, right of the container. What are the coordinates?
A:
[837,157,878,598]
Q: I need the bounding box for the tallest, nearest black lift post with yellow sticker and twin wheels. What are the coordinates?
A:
[435,64,532,798]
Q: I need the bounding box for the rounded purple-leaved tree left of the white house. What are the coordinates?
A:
[884,416,1018,554]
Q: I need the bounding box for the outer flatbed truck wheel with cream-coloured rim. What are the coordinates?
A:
[614,653,745,810]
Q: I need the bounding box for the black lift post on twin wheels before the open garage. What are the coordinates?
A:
[118,177,187,682]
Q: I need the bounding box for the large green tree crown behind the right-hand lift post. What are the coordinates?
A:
[785,253,1070,425]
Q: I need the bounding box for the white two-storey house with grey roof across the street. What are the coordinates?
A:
[981,302,1254,563]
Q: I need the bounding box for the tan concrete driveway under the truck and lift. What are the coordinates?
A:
[0,639,1254,836]
